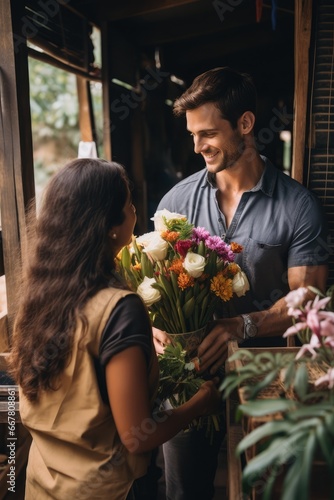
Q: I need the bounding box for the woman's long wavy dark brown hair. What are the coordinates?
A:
[9,159,129,401]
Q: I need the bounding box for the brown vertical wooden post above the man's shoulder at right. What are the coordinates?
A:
[291,0,312,183]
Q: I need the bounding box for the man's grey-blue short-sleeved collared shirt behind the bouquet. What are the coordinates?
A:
[158,157,329,330]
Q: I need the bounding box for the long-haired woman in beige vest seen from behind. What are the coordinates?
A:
[11,159,220,500]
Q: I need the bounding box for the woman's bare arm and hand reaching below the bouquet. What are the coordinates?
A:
[106,346,221,454]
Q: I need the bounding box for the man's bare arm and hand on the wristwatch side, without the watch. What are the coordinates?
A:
[198,265,328,373]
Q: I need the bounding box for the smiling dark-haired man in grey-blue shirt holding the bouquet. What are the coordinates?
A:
[154,67,328,500]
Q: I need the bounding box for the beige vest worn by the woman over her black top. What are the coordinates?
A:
[20,288,158,500]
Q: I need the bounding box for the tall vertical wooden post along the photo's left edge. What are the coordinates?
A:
[0,0,34,333]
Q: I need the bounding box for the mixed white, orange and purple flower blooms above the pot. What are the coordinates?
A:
[119,210,249,333]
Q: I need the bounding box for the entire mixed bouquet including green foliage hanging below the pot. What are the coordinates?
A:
[118,210,249,438]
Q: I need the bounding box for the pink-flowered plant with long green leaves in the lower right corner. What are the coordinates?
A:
[221,287,334,500]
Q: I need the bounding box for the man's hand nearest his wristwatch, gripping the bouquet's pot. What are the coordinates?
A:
[197,316,243,374]
